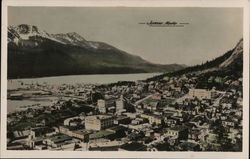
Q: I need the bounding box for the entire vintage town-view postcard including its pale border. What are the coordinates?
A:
[1,0,249,157]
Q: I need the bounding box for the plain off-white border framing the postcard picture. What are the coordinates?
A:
[0,0,249,159]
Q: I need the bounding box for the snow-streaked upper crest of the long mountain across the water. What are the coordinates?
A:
[8,24,133,50]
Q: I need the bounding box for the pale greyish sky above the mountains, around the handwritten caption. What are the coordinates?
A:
[8,7,243,65]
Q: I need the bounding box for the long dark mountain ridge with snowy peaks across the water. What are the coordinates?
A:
[8,24,184,78]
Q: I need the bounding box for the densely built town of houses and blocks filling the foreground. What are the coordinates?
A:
[7,75,243,151]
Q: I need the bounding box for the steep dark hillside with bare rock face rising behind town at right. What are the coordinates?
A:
[148,39,243,81]
